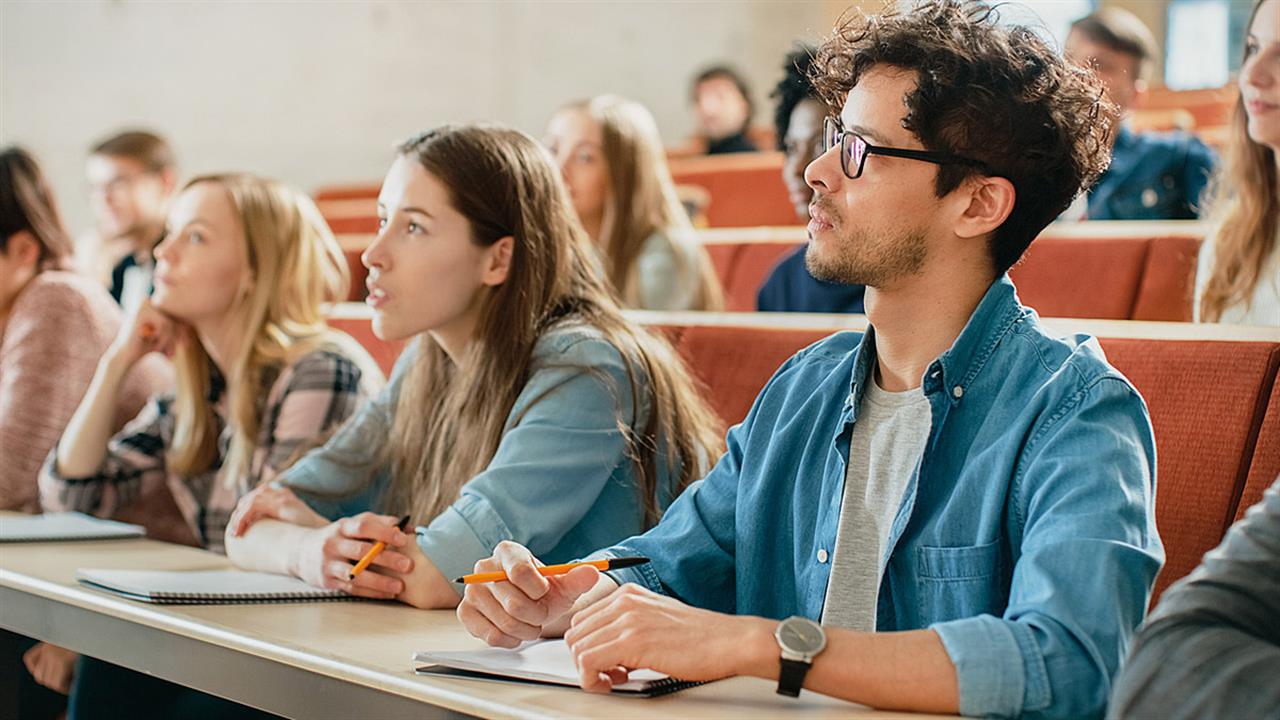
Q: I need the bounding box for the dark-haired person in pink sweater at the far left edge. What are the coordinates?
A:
[0,147,172,717]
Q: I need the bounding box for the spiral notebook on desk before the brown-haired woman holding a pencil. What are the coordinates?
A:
[76,568,355,605]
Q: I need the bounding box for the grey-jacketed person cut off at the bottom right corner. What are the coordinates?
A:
[1107,474,1280,720]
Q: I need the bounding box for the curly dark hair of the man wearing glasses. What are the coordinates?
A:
[810,0,1119,274]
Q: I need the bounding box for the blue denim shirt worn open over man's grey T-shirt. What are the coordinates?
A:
[598,277,1164,717]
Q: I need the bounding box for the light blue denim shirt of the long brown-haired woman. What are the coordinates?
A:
[279,324,675,589]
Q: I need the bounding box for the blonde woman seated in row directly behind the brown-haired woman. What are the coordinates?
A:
[547,95,723,310]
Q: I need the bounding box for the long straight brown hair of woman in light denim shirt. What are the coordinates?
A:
[387,126,722,524]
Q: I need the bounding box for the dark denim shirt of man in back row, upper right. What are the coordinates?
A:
[1088,126,1215,220]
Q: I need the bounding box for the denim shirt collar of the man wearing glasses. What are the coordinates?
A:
[845,274,1025,421]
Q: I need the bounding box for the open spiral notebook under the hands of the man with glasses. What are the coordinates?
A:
[413,641,703,697]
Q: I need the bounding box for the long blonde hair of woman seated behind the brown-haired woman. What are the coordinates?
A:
[564,95,724,310]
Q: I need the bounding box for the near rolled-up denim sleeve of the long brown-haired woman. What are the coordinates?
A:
[417,337,648,586]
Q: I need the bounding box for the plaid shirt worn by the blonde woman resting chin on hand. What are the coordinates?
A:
[40,350,381,552]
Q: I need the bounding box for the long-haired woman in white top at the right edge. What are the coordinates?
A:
[1196,0,1280,325]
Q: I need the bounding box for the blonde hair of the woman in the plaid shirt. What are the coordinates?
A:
[168,174,367,482]
